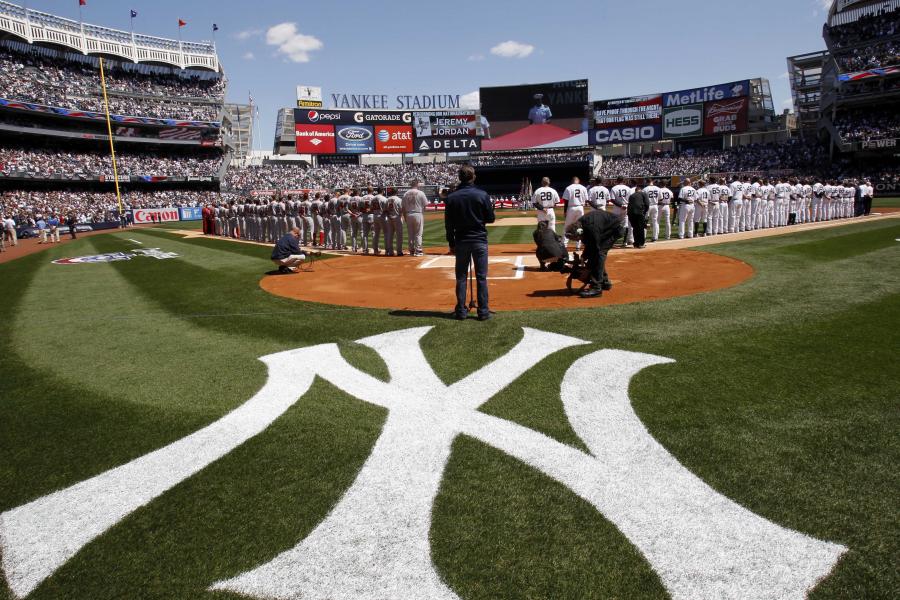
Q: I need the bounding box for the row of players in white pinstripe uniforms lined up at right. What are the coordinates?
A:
[532,177,874,248]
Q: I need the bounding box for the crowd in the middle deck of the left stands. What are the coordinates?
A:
[0,146,222,179]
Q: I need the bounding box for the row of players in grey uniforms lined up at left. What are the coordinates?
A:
[204,182,428,256]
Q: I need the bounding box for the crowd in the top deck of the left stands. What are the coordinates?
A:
[0,43,225,121]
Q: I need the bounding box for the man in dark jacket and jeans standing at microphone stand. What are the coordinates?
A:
[444,165,494,321]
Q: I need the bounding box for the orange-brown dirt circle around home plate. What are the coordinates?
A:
[260,245,753,311]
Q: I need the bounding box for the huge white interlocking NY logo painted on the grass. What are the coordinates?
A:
[0,327,846,600]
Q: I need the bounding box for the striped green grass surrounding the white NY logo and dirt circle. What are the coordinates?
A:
[0,219,900,600]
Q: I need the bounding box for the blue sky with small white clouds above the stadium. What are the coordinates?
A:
[22,0,829,149]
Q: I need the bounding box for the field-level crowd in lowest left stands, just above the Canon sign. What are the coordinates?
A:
[0,190,224,227]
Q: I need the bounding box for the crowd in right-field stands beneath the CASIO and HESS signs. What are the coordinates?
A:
[599,140,827,177]
